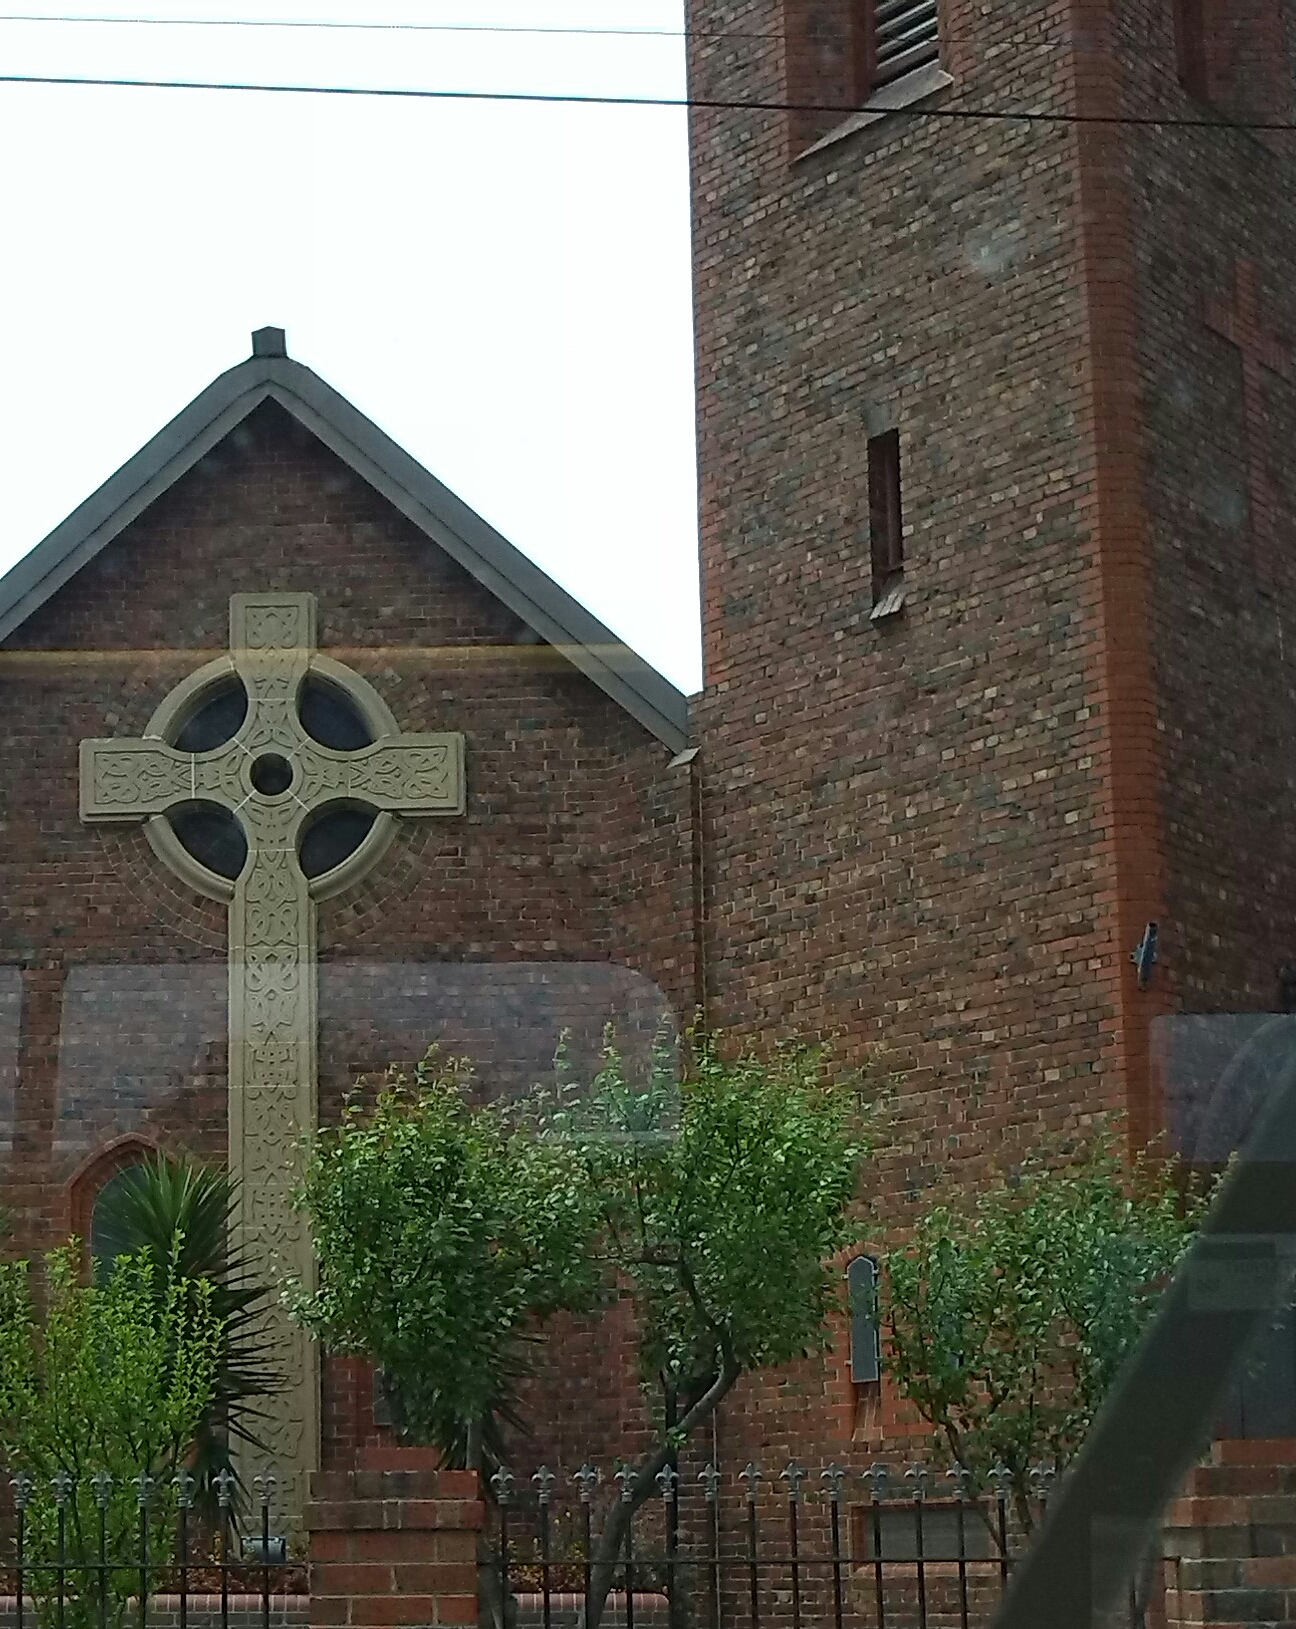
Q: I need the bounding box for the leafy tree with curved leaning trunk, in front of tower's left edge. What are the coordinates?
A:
[547,1041,873,1622]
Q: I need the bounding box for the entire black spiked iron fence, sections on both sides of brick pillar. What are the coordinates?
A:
[0,1461,1149,1629]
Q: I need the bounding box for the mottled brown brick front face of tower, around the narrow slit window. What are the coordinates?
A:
[694,3,1120,1244]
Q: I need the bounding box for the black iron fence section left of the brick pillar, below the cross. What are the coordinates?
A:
[0,1471,297,1629]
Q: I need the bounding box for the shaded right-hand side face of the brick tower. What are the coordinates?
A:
[1119,3,1296,1012]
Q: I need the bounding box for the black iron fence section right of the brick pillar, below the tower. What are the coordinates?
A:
[480,1461,1149,1629]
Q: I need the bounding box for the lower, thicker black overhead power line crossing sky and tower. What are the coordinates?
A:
[0,73,1296,132]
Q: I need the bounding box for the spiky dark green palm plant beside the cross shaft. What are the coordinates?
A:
[94,1153,283,1515]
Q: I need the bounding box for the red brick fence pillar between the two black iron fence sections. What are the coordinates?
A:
[306,1469,485,1629]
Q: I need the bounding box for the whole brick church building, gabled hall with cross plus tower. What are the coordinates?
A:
[0,0,1296,1550]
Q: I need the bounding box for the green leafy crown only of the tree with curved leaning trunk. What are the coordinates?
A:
[581,1044,866,1404]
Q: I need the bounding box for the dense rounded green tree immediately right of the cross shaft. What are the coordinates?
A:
[295,1056,602,1476]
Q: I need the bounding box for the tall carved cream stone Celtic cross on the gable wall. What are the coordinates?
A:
[81,595,464,1520]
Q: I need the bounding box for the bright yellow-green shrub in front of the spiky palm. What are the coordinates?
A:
[0,1240,223,1629]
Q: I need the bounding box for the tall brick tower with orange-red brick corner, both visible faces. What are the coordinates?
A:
[689,0,1296,1455]
